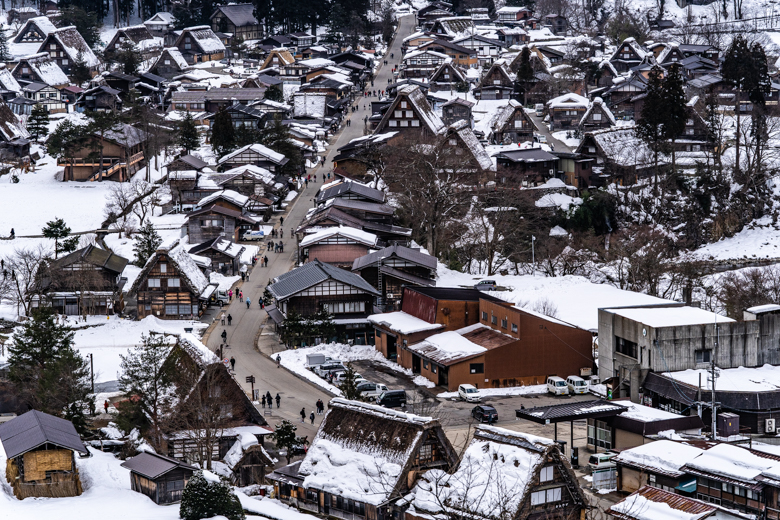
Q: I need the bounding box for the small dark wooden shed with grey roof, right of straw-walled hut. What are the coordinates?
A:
[122,452,198,504]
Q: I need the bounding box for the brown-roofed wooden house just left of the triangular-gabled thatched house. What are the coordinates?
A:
[32,245,129,316]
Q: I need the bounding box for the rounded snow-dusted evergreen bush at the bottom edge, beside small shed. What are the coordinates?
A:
[179,471,246,520]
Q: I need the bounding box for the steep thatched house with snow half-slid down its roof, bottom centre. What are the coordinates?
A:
[267,398,458,520]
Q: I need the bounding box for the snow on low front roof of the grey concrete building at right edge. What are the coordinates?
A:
[663,365,780,392]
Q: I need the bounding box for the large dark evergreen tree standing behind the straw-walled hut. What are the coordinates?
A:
[8,309,93,432]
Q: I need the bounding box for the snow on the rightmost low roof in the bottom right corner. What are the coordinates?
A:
[685,443,780,483]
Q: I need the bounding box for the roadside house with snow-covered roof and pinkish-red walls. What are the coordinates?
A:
[298,226,377,269]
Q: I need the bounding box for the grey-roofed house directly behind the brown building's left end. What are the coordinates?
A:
[352,244,436,312]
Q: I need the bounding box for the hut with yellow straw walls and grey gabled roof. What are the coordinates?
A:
[0,410,89,498]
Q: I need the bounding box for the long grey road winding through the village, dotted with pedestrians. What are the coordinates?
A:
[207,15,414,440]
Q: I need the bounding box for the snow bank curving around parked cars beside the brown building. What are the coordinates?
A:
[279,343,435,395]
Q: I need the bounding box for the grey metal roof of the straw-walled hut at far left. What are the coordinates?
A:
[0,410,88,459]
